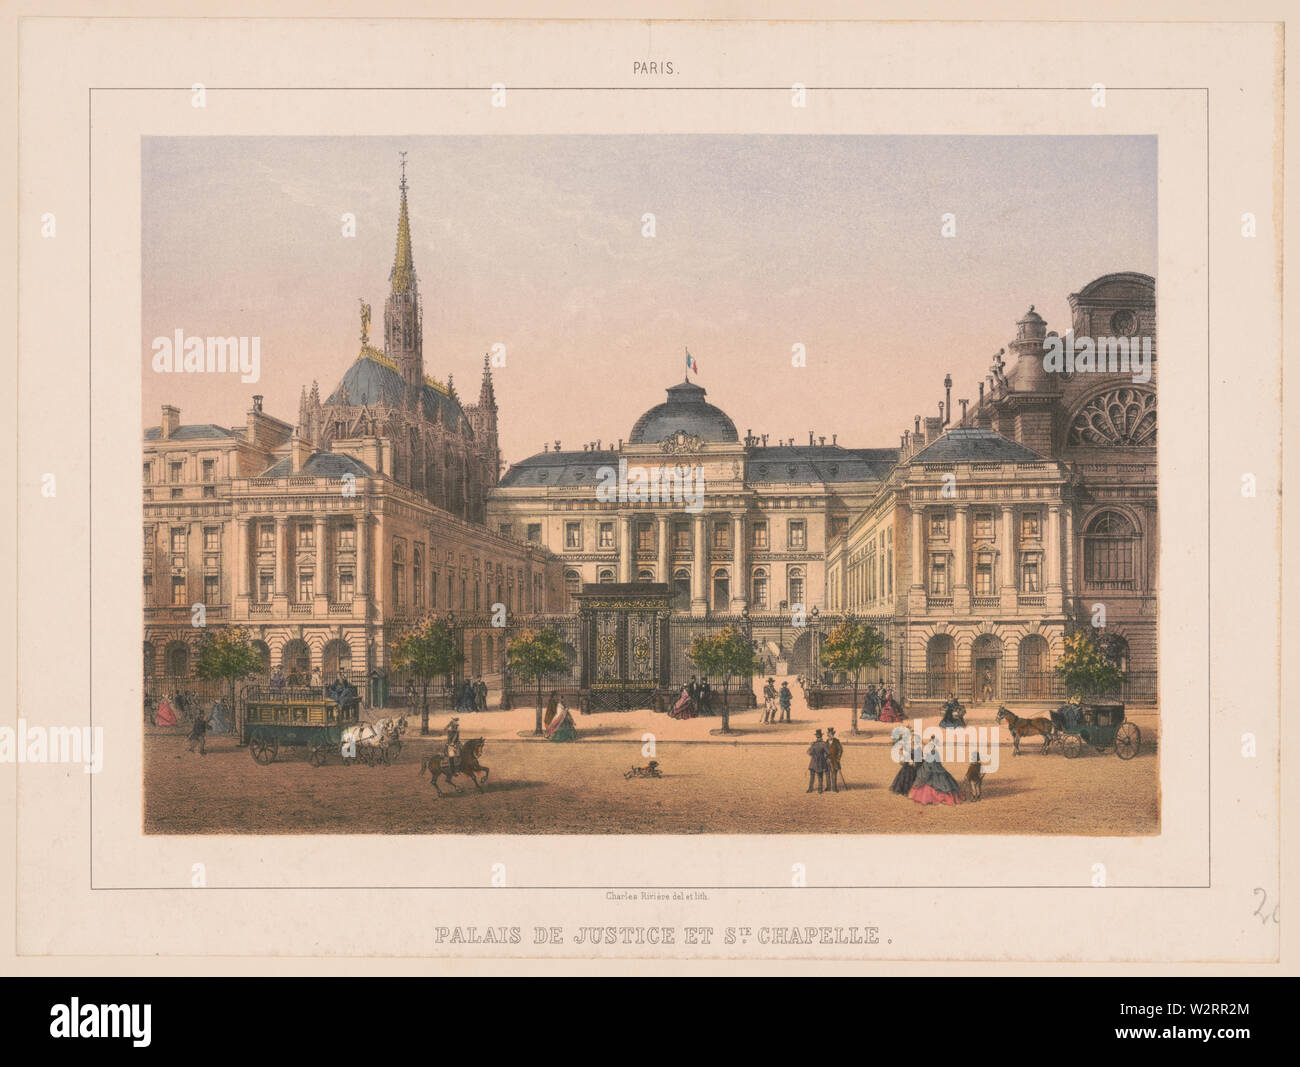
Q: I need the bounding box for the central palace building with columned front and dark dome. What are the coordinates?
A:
[488,382,898,616]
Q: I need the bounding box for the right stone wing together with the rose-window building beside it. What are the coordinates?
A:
[827,273,1160,701]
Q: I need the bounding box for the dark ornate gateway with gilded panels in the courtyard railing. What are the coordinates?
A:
[573,582,672,711]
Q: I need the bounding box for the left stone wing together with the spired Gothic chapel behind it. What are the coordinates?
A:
[143,163,563,678]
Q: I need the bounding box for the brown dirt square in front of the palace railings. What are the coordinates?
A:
[144,708,1160,836]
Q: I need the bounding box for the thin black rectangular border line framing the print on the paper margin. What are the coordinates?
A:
[86,84,1214,893]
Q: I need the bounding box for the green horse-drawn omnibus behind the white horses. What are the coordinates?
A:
[241,682,361,767]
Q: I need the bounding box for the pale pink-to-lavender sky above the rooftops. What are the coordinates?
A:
[142,135,1158,461]
